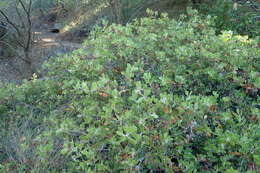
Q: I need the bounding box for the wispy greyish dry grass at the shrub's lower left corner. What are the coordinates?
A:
[0,120,67,173]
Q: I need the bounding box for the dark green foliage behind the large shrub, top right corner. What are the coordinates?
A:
[199,0,260,37]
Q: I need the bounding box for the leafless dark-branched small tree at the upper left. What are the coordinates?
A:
[0,0,33,77]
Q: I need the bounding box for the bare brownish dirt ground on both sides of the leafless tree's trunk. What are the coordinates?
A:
[0,25,82,84]
